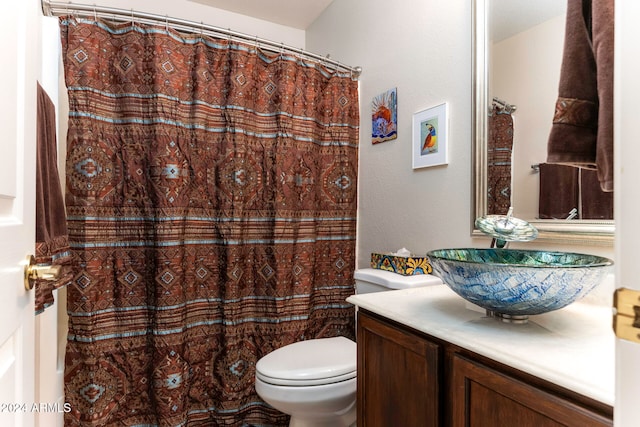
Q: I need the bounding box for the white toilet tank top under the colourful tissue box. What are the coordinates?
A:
[353,268,442,294]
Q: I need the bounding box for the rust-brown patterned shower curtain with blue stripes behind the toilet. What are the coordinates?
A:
[60,17,359,426]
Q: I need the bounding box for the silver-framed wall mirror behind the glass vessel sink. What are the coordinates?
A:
[472,0,614,244]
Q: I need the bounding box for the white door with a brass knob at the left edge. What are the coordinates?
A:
[0,0,40,427]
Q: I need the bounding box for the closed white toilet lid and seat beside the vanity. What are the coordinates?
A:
[256,337,356,386]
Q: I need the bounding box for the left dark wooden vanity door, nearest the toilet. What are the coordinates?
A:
[358,310,439,427]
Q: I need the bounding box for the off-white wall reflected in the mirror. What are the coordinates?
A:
[489,15,566,218]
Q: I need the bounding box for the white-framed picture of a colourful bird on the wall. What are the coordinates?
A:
[412,102,449,169]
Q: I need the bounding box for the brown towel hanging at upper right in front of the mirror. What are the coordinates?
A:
[547,0,614,192]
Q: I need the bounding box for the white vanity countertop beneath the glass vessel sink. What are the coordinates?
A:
[347,285,615,406]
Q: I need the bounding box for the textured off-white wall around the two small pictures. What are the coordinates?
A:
[306,0,613,268]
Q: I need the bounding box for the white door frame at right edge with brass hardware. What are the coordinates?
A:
[613,0,640,427]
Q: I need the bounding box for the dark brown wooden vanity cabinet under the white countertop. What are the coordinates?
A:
[357,309,613,427]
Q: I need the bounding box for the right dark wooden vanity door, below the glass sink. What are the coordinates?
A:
[451,355,613,427]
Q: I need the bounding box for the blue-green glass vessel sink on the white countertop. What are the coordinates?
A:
[427,248,613,321]
